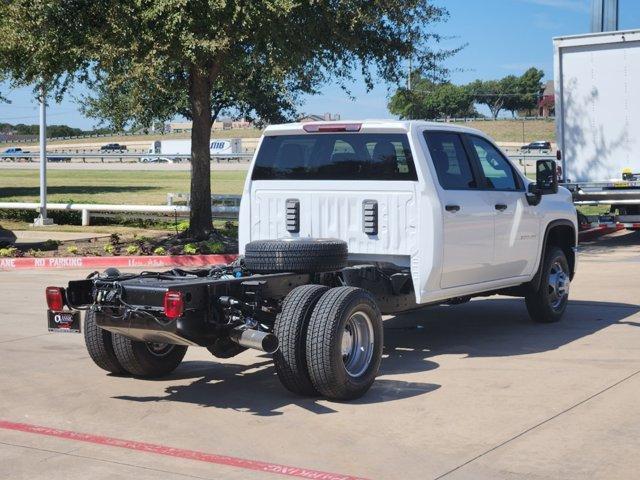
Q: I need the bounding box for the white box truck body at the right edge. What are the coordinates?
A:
[553,30,640,228]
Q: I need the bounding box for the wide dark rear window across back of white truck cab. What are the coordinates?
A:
[251,133,417,181]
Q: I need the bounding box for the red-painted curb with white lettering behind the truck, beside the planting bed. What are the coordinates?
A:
[0,254,238,271]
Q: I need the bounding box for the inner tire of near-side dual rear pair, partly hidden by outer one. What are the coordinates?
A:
[273,285,329,396]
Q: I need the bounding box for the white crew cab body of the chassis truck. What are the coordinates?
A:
[240,121,577,304]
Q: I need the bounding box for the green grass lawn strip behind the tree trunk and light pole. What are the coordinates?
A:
[0,169,246,205]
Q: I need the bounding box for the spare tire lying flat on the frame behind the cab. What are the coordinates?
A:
[244,238,348,273]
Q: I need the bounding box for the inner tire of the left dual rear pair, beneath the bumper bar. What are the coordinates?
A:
[113,335,187,378]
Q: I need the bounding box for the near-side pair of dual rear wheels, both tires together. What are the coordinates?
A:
[274,285,383,400]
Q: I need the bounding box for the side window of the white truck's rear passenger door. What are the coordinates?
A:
[424,131,478,190]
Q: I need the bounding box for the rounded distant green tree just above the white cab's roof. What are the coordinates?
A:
[388,75,475,119]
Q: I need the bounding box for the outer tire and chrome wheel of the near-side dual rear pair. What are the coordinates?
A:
[307,287,383,400]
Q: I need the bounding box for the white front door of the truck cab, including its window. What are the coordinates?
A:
[466,134,540,280]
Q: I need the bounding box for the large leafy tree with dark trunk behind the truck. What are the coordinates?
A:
[0,0,447,238]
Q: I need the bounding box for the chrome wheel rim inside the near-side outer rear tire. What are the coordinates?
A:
[341,311,374,377]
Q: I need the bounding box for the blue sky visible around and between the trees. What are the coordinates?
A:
[0,0,640,129]
